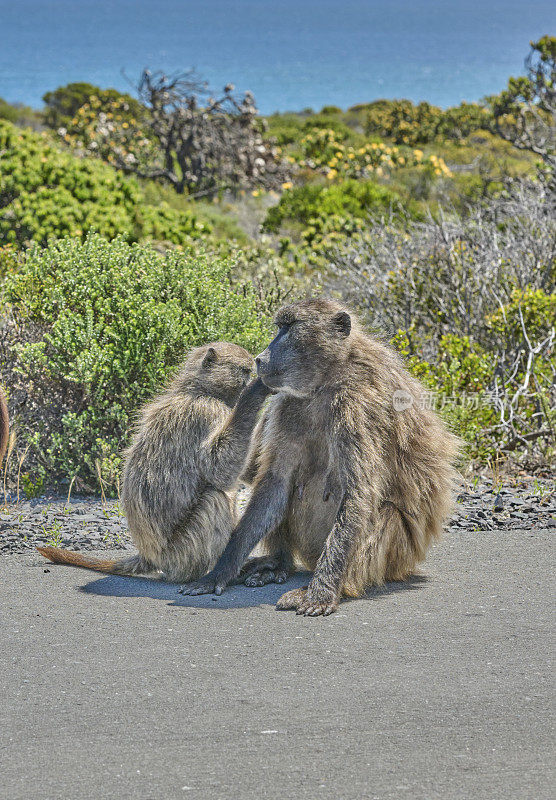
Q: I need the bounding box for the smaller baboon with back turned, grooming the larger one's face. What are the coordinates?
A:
[37,342,270,581]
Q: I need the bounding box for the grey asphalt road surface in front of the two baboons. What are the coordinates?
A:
[0,531,554,800]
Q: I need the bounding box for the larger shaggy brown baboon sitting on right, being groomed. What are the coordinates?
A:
[180,299,458,616]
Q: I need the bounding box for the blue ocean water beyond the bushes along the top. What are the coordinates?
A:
[0,0,556,113]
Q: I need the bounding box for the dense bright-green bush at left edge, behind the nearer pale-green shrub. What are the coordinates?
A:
[0,120,208,246]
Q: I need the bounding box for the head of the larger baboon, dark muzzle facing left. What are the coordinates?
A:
[255,301,351,397]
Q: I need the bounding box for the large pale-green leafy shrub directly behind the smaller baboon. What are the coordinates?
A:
[4,234,270,490]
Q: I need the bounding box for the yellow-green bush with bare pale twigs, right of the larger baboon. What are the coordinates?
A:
[393,288,556,464]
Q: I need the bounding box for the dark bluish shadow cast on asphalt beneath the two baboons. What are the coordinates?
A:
[79,572,427,609]
